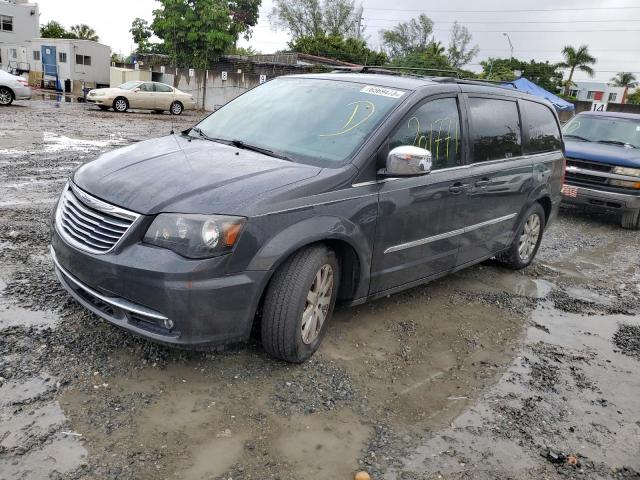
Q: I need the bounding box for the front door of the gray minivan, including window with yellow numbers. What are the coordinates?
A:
[370,96,469,293]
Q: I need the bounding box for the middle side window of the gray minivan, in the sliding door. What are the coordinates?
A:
[469,98,522,163]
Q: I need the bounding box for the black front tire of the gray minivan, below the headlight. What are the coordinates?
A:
[261,245,340,363]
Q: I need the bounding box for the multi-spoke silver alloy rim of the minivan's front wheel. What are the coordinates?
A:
[301,263,333,345]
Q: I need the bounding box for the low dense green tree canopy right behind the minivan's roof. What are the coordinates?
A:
[289,35,387,65]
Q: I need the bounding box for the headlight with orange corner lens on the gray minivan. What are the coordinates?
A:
[144,213,247,258]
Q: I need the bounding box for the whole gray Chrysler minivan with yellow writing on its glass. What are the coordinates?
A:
[51,72,564,362]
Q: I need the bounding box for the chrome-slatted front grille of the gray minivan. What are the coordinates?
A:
[56,184,138,253]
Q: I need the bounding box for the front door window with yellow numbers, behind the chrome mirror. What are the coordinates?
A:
[389,98,462,170]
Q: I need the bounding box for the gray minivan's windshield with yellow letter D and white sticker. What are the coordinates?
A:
[195,78,406,166]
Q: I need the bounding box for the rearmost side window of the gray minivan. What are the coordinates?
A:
[522,100,562,153]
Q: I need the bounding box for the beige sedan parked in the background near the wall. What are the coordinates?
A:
[87,81,196,115]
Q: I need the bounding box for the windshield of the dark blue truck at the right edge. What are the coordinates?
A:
[562,115,640,148]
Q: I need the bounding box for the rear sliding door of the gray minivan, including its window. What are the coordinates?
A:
[458,96,533,265]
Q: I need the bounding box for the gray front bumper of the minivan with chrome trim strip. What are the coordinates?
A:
[51,227,268,348]
